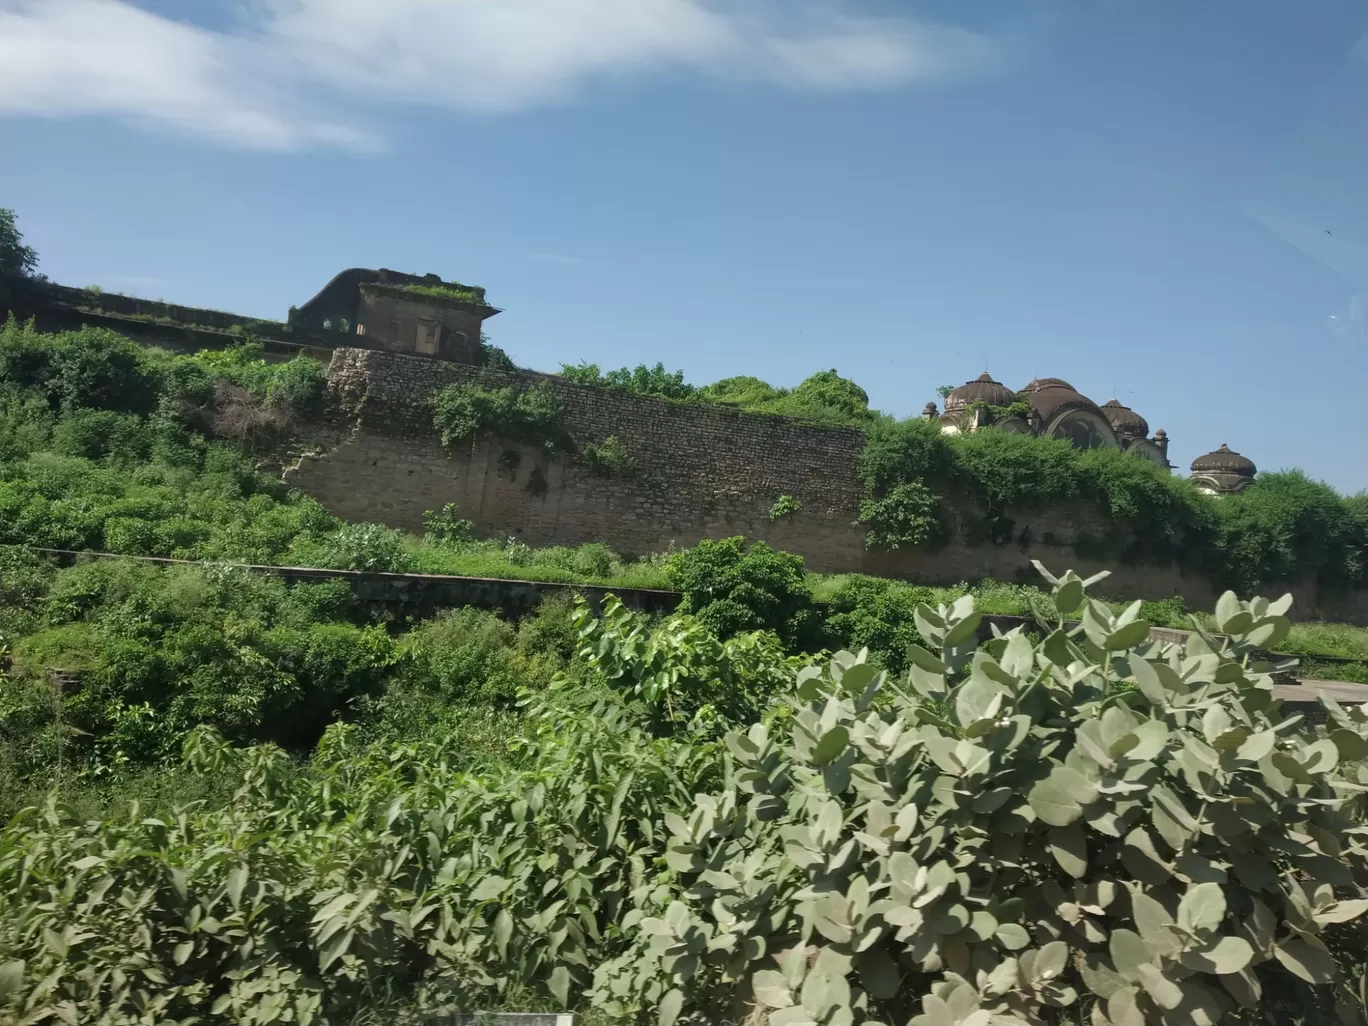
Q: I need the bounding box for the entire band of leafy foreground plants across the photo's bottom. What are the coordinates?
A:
[0,566,1368,1026]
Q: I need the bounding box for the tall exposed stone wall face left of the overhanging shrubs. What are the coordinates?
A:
[286,349,865,570]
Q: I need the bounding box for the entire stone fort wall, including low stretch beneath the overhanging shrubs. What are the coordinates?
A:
[285,349,1368,622]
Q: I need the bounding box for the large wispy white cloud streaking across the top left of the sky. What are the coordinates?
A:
[0,0,992,149]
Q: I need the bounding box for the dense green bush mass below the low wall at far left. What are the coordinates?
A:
[0,561,394,793]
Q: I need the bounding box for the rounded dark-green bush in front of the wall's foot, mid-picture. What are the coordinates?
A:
[665,538,818,650]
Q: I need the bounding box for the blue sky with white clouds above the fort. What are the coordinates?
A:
[0,0,1368,492]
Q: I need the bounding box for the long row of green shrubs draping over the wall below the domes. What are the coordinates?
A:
[858,419,1368,590]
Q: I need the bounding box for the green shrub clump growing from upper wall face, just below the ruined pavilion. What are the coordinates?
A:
[431,382,575,457]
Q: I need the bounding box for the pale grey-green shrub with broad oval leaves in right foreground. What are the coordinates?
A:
[598,575,1368,1026]
